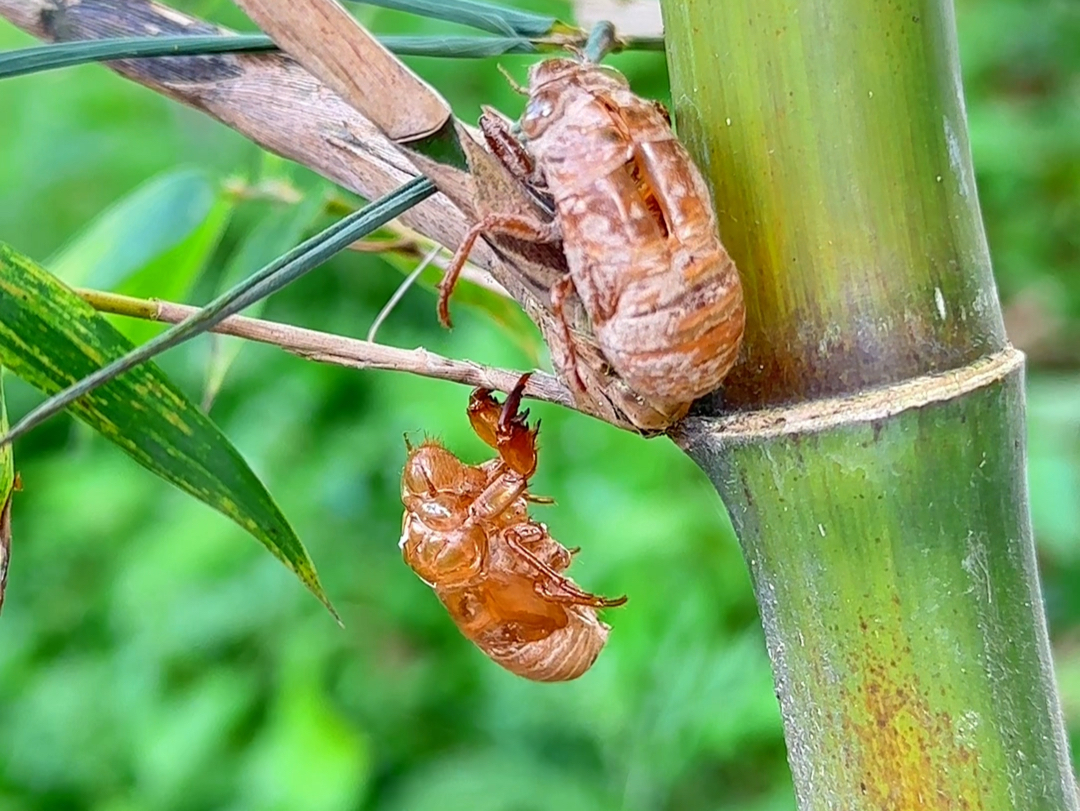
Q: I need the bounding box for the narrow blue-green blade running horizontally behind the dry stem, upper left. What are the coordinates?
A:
[0,30,537,79]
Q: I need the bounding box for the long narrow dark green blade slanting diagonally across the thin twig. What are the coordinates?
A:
[0,177,435,445]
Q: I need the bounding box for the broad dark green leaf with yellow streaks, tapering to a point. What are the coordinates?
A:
[0,243,337,617]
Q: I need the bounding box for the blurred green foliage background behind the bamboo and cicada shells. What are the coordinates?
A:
[0,0,1080,811]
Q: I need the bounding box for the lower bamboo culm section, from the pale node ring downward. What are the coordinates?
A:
[677,358,1078,811]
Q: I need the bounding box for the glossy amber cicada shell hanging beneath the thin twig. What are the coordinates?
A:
[401,375,626,681]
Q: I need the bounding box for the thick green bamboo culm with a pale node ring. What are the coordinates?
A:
[662,0,1078,811]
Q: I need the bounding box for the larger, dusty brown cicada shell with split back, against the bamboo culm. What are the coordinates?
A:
[441,59,745,422]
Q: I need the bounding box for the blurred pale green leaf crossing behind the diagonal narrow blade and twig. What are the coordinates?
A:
[202,194,324,409]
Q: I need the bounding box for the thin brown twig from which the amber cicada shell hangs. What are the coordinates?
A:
[77,289,573,408]
